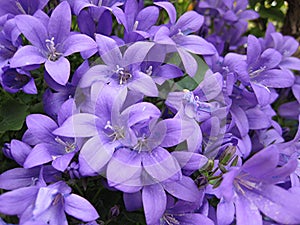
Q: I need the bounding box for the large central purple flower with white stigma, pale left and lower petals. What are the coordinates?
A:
[54,85,160,175]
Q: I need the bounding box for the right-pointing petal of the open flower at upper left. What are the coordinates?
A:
[63,34,97,56]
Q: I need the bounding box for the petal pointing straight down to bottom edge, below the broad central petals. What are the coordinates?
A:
[142,184,167,224]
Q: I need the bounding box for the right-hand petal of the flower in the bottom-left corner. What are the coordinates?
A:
[64,194,99,222]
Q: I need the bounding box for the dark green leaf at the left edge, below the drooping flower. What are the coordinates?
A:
[0,99,29,133]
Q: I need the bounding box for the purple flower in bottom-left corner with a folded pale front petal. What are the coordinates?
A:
[0,181,99,225]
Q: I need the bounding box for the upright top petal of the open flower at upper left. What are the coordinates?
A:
[48,1,71,43]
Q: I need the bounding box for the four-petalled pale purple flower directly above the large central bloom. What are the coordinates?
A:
[79,34,158,97]
